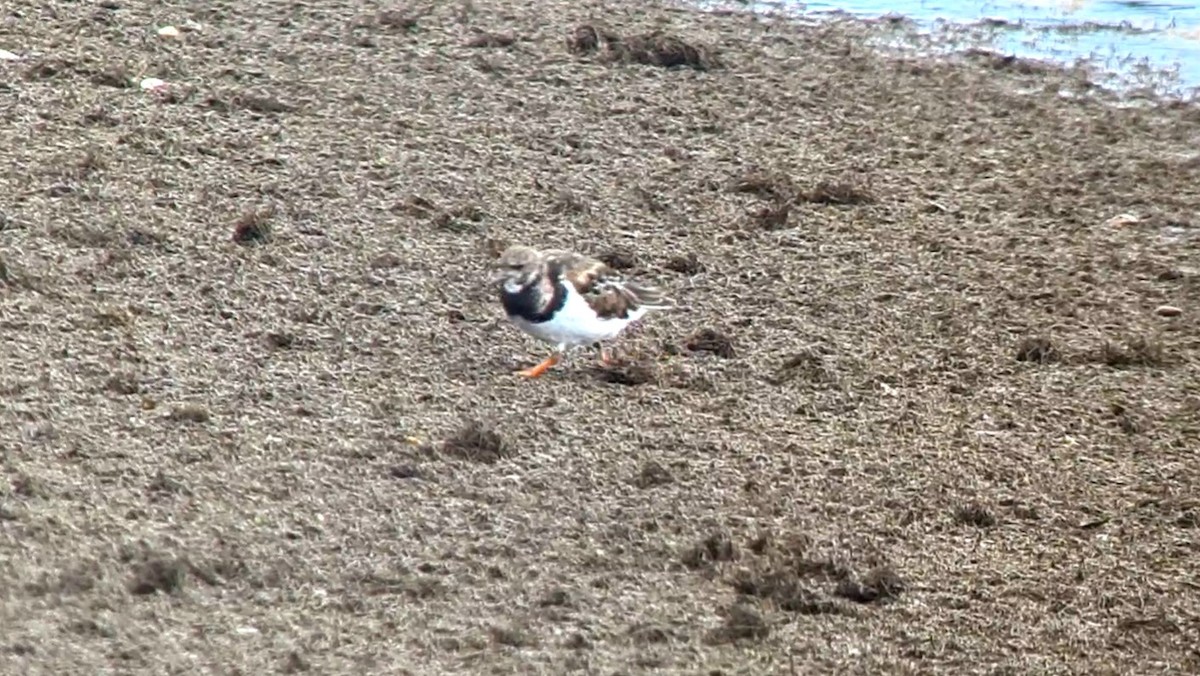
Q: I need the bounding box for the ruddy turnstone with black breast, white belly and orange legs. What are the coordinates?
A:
[494,246,671,378]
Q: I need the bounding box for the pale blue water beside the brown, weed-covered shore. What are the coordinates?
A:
[700,0,1200,97]
